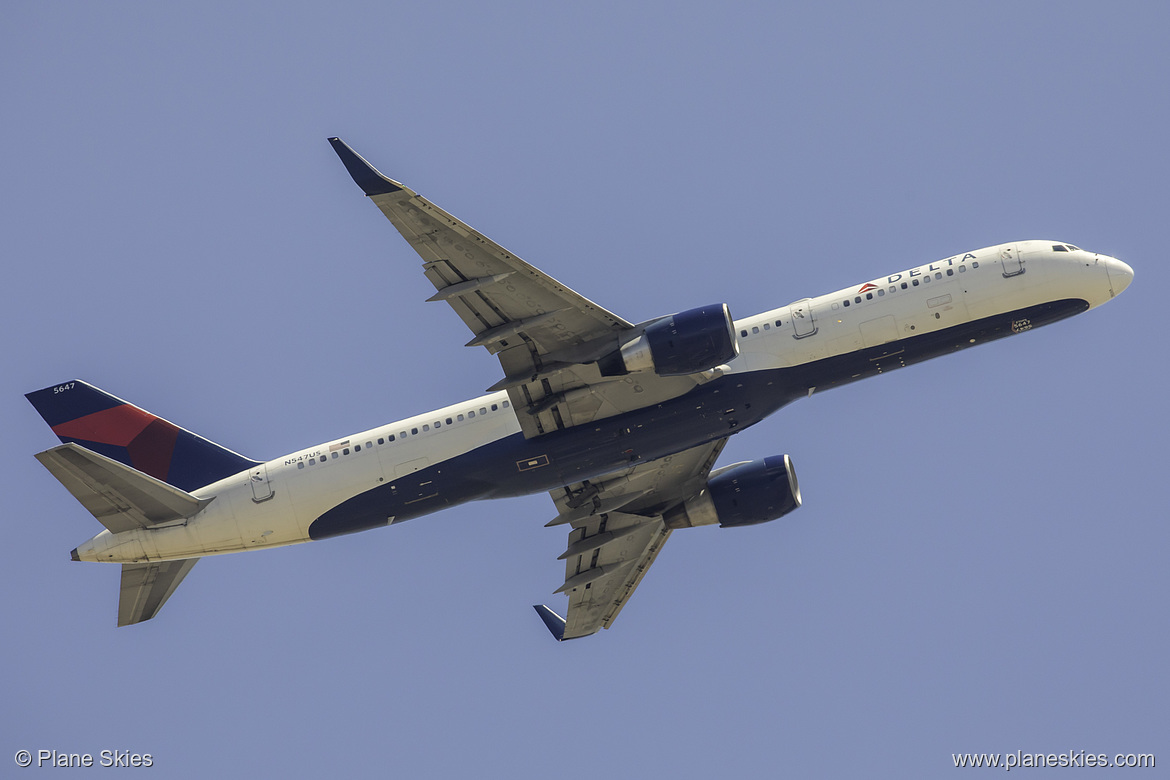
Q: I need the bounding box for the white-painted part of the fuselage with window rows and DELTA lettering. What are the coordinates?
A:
[77,241,1133,564]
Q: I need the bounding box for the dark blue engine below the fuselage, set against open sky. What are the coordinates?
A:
[662,455,800,529]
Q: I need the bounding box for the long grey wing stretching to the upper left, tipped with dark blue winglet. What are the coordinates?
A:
[329,138,716,437]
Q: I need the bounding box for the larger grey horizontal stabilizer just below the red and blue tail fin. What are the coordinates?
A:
[36,444,212,533]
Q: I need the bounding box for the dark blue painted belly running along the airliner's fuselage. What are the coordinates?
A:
[309,295,1088,539]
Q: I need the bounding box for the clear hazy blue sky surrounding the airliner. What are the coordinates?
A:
[0,2,1170,778]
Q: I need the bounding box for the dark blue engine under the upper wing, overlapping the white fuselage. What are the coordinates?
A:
[598,303,739,377]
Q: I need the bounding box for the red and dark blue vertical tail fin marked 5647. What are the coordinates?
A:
[25,380,257,491]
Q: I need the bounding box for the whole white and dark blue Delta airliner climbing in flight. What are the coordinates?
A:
[27,138,1134,641]
